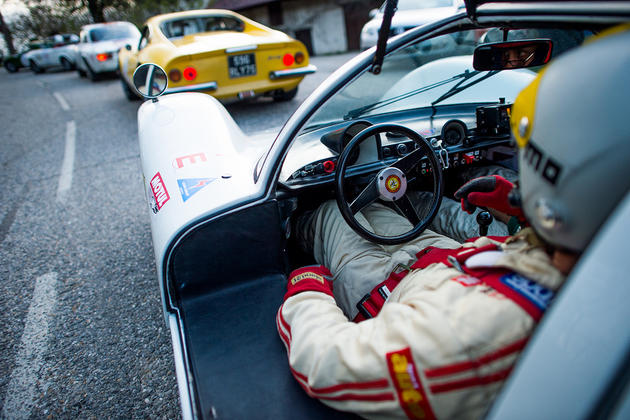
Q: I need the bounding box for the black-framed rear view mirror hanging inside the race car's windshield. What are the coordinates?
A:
[473,39,553,70]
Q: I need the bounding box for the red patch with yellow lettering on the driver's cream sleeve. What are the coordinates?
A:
[386,347,435,419]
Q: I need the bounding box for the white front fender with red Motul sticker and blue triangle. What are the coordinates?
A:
[138,93,273,316]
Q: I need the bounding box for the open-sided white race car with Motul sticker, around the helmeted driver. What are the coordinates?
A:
[134,0,630,419]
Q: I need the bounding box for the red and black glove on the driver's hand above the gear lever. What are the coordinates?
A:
[455,175,525,220]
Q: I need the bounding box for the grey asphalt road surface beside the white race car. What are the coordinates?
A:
[0,50,354,419]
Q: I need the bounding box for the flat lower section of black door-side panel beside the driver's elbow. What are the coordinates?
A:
[183,275,358,420]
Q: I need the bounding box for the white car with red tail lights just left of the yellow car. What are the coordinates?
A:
[76,22,140,81]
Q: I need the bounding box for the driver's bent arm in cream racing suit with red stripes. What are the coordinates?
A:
[277,263,532,418]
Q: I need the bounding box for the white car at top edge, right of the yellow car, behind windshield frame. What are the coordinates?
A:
[361,0,464,51]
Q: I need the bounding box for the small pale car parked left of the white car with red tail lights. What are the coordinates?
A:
[20,34,79,73]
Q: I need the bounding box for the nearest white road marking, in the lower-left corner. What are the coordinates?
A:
[0,272,57,419]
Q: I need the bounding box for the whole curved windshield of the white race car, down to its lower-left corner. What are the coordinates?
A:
[280,28,591,181]
